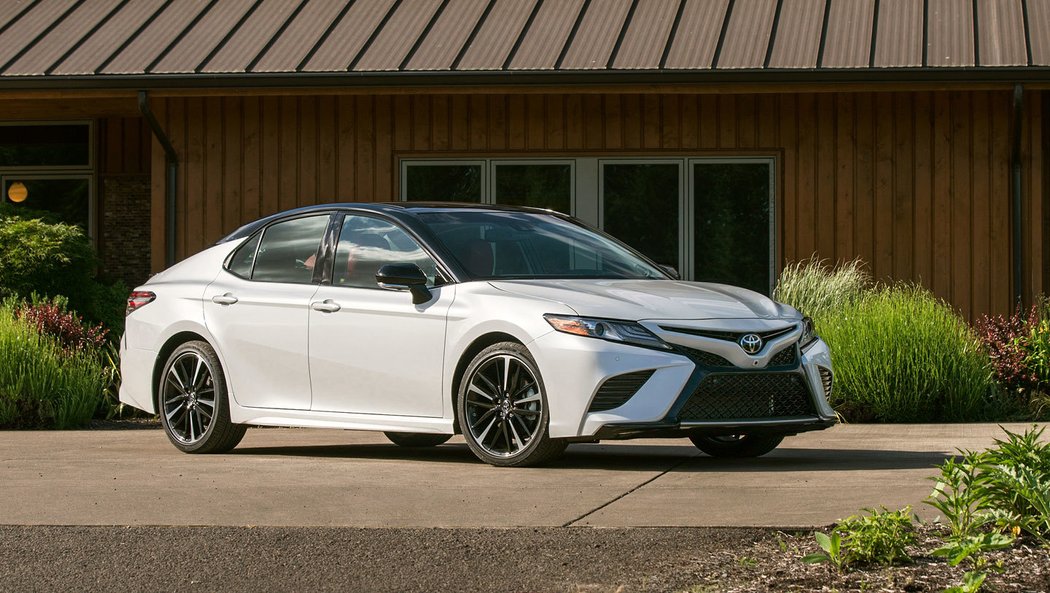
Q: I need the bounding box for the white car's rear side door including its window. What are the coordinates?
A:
[204,213,330,409]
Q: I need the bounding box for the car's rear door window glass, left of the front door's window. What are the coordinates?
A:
[252,214,329,284]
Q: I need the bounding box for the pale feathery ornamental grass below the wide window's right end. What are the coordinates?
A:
[773,256,872,319]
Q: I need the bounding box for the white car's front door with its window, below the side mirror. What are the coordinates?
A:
[310,214,455,417]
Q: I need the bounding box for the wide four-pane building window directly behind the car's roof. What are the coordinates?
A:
[400,156,776,294]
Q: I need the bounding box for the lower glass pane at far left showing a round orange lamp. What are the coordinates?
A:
[3,177,90,231]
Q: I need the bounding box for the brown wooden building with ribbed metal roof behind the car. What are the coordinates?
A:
[0,0,1050,318]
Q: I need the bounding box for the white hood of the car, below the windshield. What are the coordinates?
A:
[491,280,798,321]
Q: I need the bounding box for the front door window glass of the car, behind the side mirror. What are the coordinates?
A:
[334,216,437,289]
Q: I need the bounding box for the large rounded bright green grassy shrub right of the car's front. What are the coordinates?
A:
[816,284,993,422]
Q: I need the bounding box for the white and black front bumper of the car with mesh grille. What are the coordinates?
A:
[530,333,837,441]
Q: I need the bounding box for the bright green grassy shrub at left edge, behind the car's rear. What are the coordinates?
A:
[0,299,107,428]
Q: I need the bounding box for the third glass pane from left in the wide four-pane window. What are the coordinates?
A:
[602,164,679,268]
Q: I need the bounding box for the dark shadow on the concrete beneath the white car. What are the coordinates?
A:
[230,443,956,472]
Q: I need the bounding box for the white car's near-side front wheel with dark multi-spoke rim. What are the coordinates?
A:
[456,342,567,467]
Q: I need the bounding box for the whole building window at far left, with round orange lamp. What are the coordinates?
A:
[0,122,95,235]
